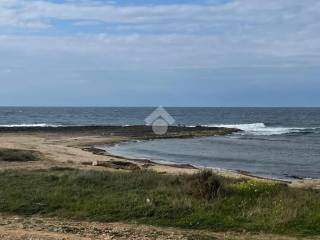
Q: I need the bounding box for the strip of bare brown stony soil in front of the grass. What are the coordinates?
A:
[0,215,320,240]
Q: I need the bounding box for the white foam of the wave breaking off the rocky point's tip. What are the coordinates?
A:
[207,123,306,136]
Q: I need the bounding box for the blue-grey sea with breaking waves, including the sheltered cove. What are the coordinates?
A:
[0,107,320,179]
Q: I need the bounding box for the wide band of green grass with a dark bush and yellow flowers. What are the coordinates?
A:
[0,168,320,236]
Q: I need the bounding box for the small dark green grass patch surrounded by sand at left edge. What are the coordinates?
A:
[0,148,40,162]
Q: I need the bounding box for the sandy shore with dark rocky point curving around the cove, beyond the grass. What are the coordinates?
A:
[0,125,320,188]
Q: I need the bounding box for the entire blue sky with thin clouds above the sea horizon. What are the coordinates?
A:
[0,0,320,107]
